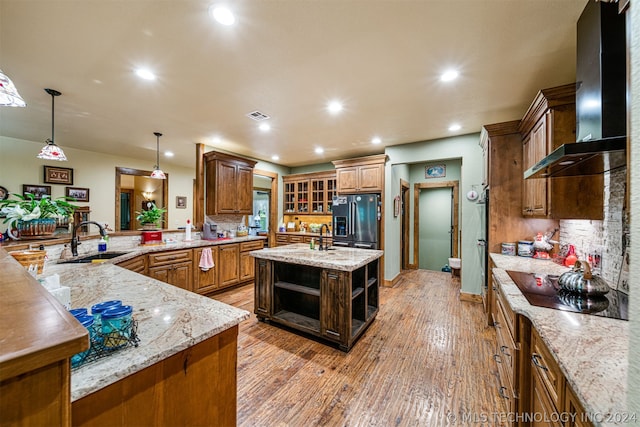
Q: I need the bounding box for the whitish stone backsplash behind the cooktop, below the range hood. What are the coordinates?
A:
[560,169,629,293]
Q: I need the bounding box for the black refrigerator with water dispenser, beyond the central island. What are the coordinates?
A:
[331,194,381,249]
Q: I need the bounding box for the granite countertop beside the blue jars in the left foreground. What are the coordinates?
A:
[43,263,249,401]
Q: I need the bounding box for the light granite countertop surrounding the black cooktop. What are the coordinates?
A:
[491,254,629,426]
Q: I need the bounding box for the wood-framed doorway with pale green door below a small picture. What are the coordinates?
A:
[413,181,459,271]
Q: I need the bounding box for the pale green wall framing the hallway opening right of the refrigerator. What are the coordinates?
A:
[384,133,482,294]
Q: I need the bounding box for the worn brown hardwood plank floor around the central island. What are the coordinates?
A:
[213,270,506,427]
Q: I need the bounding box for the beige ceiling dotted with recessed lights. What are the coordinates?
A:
[0,0,587,168]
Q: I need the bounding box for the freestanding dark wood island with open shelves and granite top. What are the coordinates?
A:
[251,244,384,351]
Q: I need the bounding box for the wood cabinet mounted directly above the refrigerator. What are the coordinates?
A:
[333,154,387,194]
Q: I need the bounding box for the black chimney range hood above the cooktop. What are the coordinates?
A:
[524,0,627,179]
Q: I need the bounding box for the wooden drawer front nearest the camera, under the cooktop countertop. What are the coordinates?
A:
[531,330,564,408]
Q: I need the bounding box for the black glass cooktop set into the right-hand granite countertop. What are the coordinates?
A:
[507,271,629,320]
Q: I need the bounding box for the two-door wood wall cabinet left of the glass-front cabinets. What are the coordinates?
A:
[204,151,256,215]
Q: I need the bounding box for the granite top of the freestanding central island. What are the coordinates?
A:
[250,243,384,271]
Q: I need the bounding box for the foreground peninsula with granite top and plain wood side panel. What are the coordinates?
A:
[3,249,249,425]
